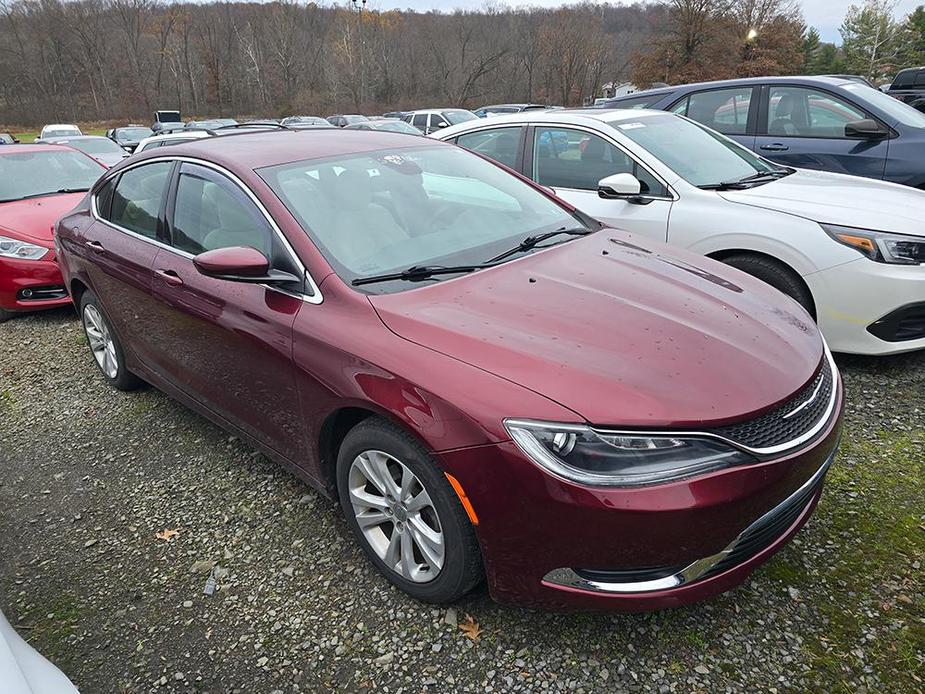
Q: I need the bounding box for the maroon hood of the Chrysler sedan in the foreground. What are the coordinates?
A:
[370,229,824,426]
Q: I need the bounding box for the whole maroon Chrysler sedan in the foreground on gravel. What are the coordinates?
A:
[58,130,842,610]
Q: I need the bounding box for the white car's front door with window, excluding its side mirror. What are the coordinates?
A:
[524,125,672,241]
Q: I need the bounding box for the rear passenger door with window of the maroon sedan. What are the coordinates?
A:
[77,161,173,364]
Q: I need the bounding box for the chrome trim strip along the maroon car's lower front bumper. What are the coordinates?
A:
[543,451,835,593]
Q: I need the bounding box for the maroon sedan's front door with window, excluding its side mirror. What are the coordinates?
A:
[146,162,305,459]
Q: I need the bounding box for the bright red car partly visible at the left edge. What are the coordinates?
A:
[0,145,106,322]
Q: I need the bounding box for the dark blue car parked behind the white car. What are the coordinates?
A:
[603,77,925,188]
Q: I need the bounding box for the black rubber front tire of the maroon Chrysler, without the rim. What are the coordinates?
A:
[337,418,482,603]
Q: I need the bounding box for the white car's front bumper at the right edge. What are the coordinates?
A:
[803,257,925,355]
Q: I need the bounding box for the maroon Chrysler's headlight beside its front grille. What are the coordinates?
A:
[504,419,757,487]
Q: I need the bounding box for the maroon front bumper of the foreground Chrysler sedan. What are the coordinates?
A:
[441,384,843,612]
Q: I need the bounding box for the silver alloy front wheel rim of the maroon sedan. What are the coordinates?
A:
[348,450,445,583]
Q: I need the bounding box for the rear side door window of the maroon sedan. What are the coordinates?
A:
[109,161,173,239]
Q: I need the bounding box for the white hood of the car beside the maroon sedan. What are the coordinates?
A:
[720,170,925,236]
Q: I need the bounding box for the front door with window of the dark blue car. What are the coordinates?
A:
[755,84,889,178]
